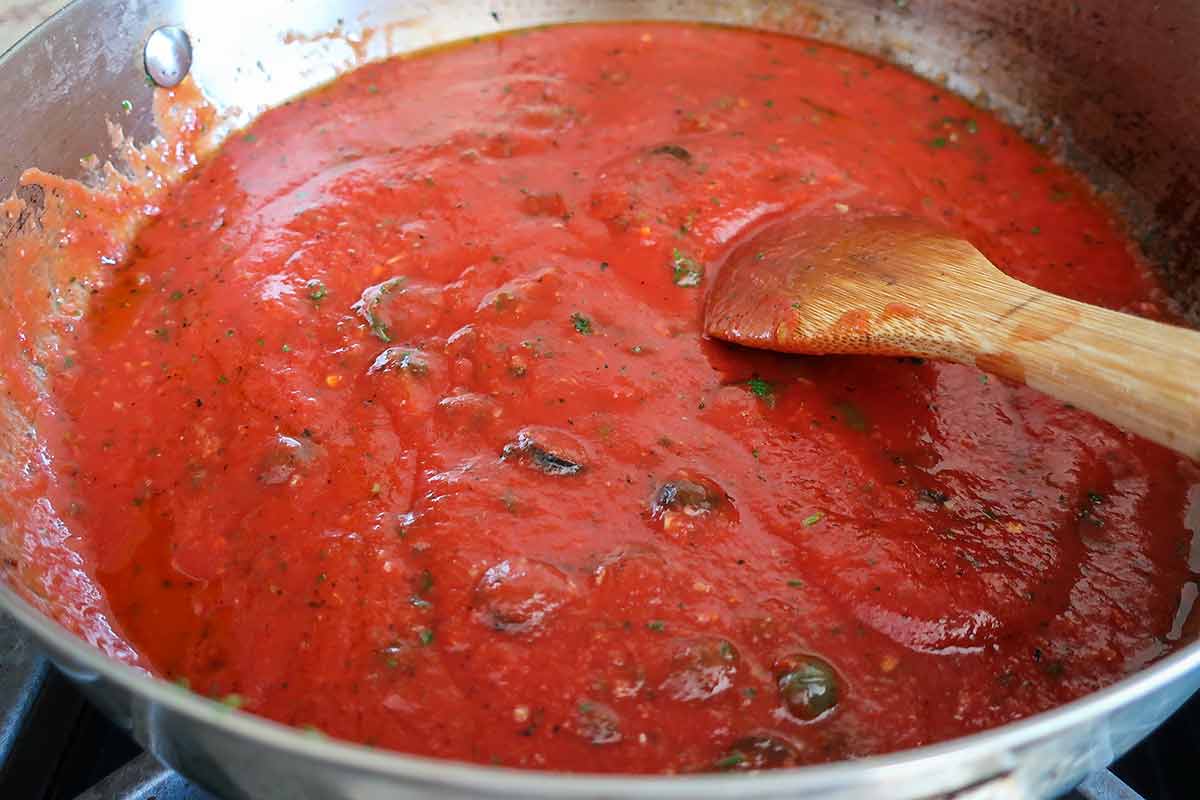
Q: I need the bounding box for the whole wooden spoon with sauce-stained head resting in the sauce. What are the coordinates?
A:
[704,217,1200,461]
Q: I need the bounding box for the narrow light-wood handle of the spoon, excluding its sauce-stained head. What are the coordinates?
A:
[974,276,1200,459]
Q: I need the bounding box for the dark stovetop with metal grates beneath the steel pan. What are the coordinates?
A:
[0,615,1200,800]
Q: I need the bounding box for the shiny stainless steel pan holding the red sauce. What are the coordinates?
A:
[0,0,1200,800]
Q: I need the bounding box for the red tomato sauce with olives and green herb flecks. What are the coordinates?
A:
[44,24,1200,772]
